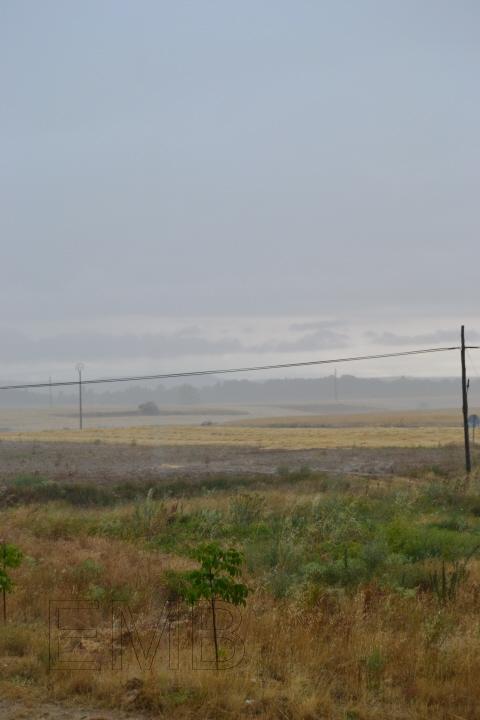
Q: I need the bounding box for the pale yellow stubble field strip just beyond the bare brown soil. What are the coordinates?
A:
[0,408,463,450]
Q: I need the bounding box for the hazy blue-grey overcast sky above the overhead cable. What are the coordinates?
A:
[0,0,480,386]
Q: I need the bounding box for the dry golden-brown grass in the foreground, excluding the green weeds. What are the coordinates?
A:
[0,476,480,720]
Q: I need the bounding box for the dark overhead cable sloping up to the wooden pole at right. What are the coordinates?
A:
[0,345,472,390]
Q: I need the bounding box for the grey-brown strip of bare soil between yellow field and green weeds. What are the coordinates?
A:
[0,441,463,483]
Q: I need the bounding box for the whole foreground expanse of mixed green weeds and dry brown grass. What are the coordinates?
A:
[0,469,480,720]
